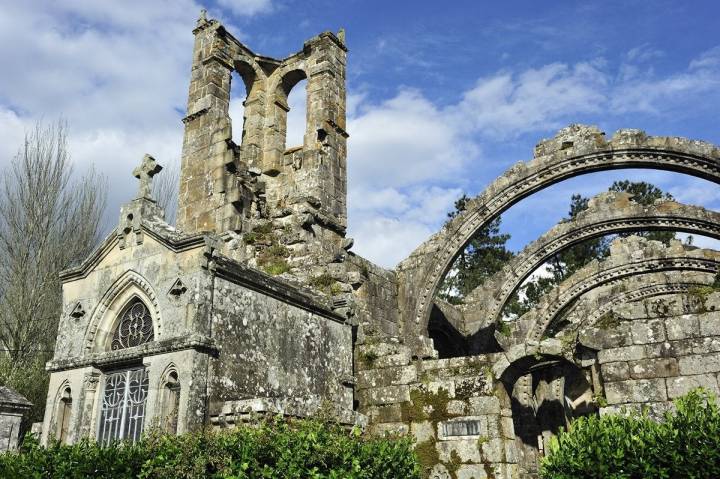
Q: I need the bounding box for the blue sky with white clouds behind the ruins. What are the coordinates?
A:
[0,0,720,266]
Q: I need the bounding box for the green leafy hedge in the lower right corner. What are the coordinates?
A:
[541,390,720,479]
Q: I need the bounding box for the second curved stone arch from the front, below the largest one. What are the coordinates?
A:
[462,193,720,334]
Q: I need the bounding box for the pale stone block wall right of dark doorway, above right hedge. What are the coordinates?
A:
[598,288,720,413]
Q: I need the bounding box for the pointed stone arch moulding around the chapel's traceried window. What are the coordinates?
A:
[84,270,163,354]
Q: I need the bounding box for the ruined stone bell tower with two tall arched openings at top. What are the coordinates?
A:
[177,11,348,239]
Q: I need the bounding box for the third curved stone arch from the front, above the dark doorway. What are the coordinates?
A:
[504,237,720,351]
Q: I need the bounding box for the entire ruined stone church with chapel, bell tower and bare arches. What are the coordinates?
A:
[42,14,720,479]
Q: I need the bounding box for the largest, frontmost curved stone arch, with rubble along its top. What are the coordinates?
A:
[397,125,720,346]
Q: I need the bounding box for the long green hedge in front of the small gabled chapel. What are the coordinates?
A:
[0,419,420,479]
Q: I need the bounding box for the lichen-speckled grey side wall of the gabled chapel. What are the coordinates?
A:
[210,270,353,424]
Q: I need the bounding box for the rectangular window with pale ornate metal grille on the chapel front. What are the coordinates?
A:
[98,369,148,445]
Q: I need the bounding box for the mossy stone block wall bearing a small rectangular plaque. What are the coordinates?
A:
[356,342,518,479]
